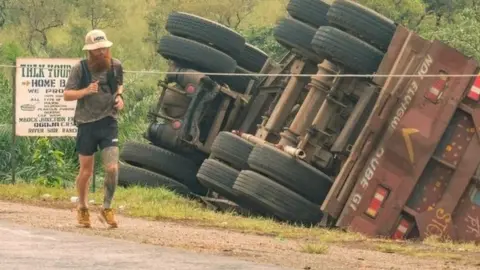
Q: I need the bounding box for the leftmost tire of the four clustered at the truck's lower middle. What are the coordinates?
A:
[197,159,239,202]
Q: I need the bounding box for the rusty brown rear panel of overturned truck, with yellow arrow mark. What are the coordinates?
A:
[337,34,480,242]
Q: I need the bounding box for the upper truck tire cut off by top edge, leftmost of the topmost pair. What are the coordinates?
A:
[287,0,330,28]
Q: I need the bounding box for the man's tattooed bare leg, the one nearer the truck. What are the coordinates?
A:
[102,146,119,209]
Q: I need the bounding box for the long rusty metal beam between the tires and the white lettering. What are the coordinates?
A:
[321,27,430,219]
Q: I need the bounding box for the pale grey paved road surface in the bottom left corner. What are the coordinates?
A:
[0,220,288,270]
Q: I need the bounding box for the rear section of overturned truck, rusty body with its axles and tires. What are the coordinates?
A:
[201,0,480,241]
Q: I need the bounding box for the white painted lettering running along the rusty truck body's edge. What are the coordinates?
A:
[347,54,433,211]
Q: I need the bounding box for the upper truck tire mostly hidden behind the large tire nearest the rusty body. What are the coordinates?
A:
[273,18,323,63]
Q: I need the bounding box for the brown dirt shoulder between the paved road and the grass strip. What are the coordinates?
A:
[0,201,478,270]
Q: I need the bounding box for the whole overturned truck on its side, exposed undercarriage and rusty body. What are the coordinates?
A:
[116,0,480,244]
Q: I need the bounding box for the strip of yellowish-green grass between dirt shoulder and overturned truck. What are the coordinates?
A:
[0,184,480,263]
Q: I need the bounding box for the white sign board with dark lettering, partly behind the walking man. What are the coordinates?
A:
[15,58,80,137]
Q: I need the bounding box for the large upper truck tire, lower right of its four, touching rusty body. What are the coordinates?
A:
[312,26,384,74]
